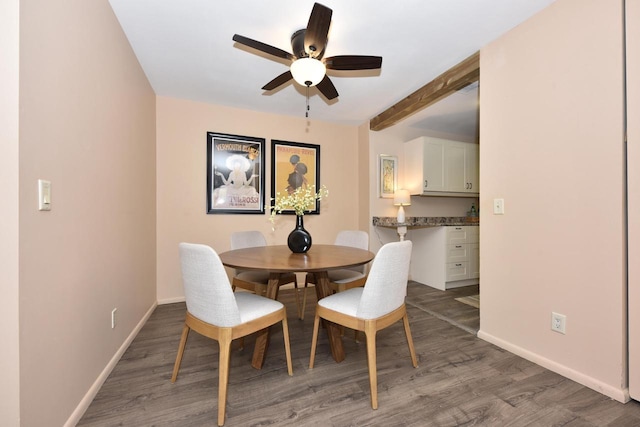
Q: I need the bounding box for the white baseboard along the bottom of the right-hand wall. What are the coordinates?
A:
[478,330,630,403]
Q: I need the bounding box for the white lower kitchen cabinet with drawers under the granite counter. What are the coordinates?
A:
[411,226,480,290]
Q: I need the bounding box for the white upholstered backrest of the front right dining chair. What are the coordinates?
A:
[356,240,412,319]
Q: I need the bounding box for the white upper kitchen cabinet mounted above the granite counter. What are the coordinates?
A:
[403,136,480,197]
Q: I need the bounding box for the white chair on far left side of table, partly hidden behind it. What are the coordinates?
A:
[231,230,302,319]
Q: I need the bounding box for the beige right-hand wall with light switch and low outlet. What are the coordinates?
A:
[479,0,627,401]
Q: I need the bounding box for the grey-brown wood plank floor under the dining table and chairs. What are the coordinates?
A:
[78,283,640,427]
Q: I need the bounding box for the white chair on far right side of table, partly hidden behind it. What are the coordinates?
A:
[300,230,369,319]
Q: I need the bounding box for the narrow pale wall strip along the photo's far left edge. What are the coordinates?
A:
[0,0,20,426]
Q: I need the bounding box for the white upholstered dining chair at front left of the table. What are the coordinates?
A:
[171,243,293,426]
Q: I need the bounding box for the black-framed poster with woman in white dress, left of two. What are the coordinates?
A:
[207,132,265,214]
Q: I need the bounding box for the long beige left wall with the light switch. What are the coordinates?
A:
[17,0,156,426]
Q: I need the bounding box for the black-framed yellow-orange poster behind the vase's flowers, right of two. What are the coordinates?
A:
[271,140,320,215]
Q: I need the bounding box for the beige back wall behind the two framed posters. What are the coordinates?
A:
[157,97,367,302]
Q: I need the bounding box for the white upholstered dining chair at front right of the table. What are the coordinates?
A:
[309,240,418,409]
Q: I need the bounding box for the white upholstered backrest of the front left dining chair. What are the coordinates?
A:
[179,243,240,326]
